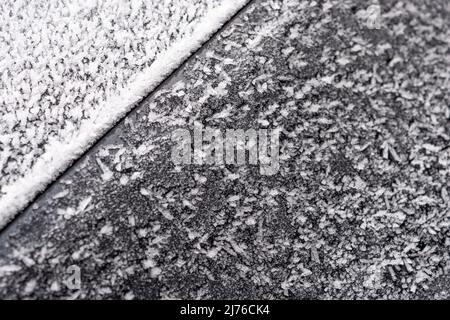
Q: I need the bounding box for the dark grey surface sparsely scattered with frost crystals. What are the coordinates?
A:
[0,0,450,299]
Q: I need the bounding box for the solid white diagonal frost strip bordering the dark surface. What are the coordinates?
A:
[0,0,249,228]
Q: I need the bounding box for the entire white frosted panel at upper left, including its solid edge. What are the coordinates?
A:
[0,0,247,226]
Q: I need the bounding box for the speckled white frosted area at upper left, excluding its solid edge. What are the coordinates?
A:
[0,0,226,201]
